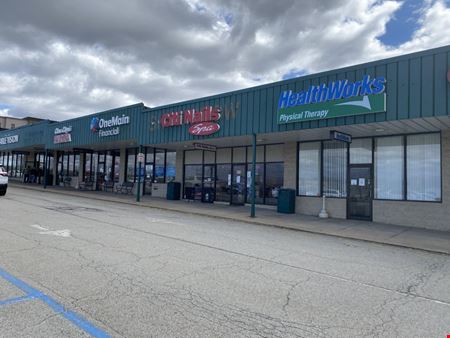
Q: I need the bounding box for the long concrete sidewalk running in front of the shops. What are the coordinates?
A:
[10,182,450,254]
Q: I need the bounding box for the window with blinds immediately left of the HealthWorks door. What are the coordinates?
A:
[323,141,347,197]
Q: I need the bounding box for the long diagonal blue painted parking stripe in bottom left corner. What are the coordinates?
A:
[0,268,109,338]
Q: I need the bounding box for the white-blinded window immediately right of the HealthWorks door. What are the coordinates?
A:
[375,136,404,200]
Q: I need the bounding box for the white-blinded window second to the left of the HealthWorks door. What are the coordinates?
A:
[298,142,321,196]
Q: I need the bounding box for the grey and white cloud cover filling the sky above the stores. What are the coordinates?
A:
[0,0,450,119]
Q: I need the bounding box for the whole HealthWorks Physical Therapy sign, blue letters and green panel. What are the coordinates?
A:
[277,75,386,124]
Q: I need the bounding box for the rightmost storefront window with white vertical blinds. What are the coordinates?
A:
[406,134,441,201]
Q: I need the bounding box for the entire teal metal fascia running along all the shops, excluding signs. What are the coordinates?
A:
[0,46,450,151]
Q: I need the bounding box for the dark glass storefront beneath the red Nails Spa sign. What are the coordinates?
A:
[183,144,284,205]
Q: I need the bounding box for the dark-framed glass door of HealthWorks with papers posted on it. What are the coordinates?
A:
[347,165,372,221]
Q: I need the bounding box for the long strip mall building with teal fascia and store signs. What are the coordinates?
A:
[0,46,450,230]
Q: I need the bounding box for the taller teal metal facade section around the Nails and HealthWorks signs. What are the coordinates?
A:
[142,46,450,144]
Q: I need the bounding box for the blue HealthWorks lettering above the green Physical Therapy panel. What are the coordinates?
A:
[278,75,386,109]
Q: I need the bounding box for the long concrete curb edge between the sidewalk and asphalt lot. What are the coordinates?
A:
[10,183,450,255]
